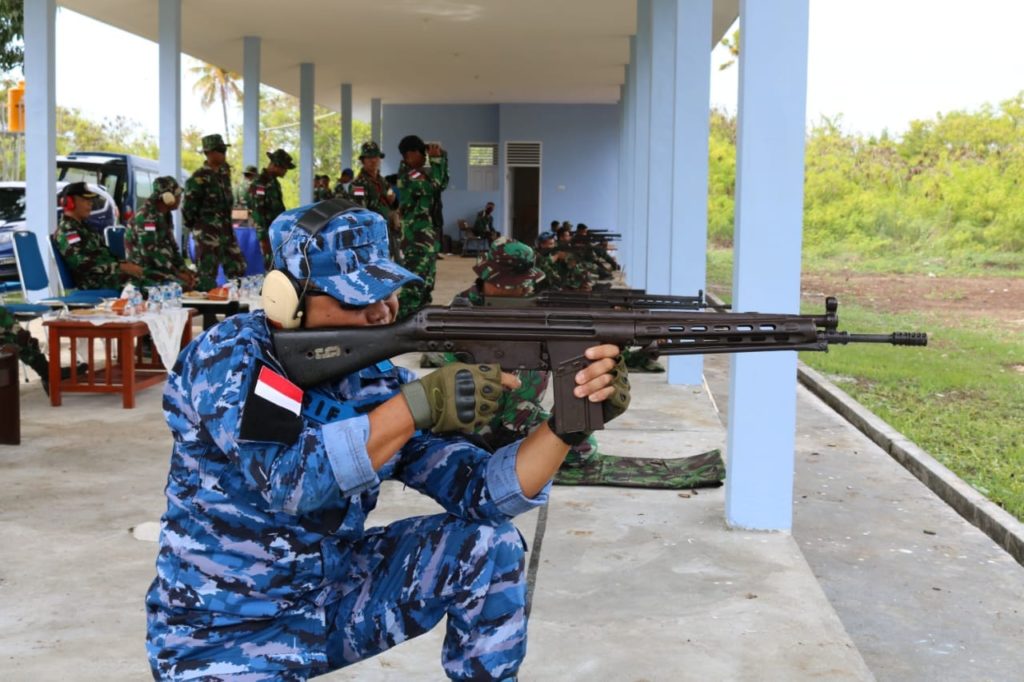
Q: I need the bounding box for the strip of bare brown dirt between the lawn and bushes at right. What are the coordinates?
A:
[801,272,1024,332]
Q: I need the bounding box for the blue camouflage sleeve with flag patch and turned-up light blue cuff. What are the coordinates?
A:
[186,334,379,514]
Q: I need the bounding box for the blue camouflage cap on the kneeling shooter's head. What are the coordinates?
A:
[270,205,423,305]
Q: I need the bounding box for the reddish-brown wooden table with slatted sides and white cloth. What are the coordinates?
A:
[43,310,196,410]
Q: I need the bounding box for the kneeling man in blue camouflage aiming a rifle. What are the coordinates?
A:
[145,200,629,680]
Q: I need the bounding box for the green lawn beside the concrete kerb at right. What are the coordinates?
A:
[708,246,1024,520]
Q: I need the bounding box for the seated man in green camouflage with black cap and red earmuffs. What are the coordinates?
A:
[53,182,142,289]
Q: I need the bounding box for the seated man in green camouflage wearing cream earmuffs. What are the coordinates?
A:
[125,175,196,291]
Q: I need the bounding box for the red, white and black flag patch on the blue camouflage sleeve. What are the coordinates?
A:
[239,363,303,444]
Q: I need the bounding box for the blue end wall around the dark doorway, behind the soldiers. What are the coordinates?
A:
[381,104,618,239]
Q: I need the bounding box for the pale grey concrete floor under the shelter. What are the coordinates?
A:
[0,257,1024,682]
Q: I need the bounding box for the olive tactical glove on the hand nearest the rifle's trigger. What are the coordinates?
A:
[400,363,502,433]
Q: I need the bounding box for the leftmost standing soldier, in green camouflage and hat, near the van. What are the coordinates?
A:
[181,134,246,291]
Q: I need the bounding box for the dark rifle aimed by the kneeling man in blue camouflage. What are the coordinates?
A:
[272,297,928,433]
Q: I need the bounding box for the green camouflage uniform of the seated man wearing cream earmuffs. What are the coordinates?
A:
[125,191,186,282]
